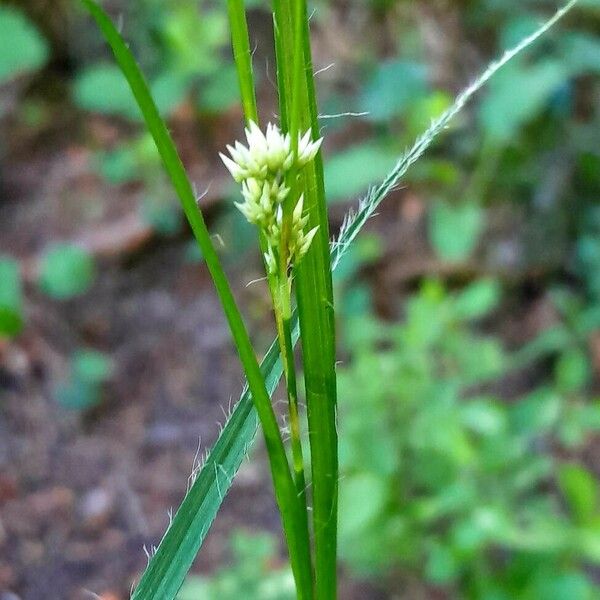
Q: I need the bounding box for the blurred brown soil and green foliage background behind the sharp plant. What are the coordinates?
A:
[0,0,600,600]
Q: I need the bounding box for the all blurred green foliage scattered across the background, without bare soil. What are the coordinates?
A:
[0,0,600,600]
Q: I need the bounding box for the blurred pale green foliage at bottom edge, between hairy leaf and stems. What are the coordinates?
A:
[177,531,296,600]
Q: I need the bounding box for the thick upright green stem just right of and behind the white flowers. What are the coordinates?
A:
[273,0,338,600]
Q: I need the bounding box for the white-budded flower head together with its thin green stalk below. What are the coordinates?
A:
[220,44,322,598]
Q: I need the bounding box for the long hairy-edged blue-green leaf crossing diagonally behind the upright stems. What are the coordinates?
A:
[90,0,576,600]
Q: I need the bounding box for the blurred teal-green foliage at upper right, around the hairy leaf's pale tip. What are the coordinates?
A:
[324,0,600,280]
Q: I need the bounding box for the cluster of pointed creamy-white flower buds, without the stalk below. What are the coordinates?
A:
[220,121,323,273]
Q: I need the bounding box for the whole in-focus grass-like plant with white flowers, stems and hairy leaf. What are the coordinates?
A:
[82,0,576,600]
